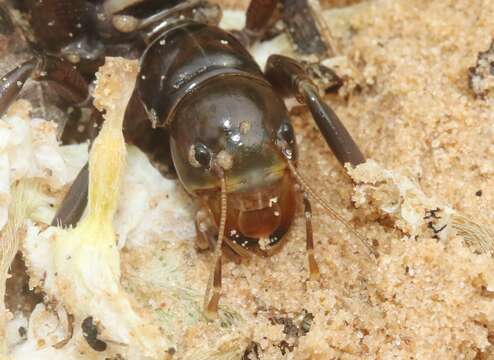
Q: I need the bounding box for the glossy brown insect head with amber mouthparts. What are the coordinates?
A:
[170,74,296,255]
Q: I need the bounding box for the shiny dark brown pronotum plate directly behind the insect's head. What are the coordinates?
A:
[136,20,264,126]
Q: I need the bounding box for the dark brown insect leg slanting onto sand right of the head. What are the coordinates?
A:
[266,55,365,166]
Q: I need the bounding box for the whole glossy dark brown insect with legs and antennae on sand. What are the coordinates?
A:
[0,0,370,318]
